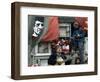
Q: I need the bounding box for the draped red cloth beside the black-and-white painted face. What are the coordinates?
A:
[42,16,60,41]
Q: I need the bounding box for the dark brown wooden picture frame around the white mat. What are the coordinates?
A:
[11,2,97,80]
